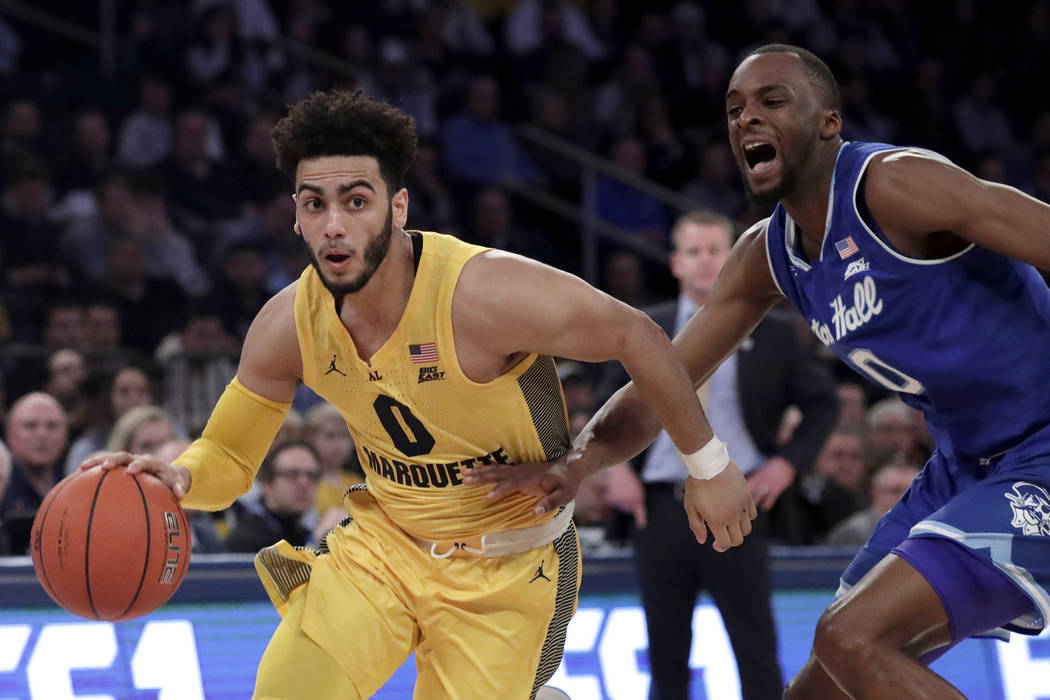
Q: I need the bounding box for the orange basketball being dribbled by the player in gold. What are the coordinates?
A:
[32,467,190,620]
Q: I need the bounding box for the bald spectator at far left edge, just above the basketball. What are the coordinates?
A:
[0,391,68,554]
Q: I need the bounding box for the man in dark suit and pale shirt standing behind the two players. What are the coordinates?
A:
[603,211,838,700]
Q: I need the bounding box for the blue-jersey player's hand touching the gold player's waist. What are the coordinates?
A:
[463,458,586,514]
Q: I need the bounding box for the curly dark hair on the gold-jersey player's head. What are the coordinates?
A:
[273,90,419,194]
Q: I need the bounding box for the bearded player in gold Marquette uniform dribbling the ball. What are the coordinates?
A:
[84,92,755,700]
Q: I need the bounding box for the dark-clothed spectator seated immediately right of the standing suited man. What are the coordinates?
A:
[793,426,867,545]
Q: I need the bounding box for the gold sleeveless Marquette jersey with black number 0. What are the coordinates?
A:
[295,232,569,539]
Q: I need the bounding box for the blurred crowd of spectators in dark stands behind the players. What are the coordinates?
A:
[0,0,1050,554]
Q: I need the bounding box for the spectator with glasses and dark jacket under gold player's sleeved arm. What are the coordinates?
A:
[226,442,321,552]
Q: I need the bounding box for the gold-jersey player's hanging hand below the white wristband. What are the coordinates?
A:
[684,462,758,552]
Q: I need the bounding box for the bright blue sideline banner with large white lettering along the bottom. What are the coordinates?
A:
[0,590,1050,700]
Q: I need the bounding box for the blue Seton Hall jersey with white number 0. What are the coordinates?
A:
[767,143,1050,469]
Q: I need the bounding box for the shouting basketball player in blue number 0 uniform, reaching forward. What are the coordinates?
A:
[471,45,1050,700]
